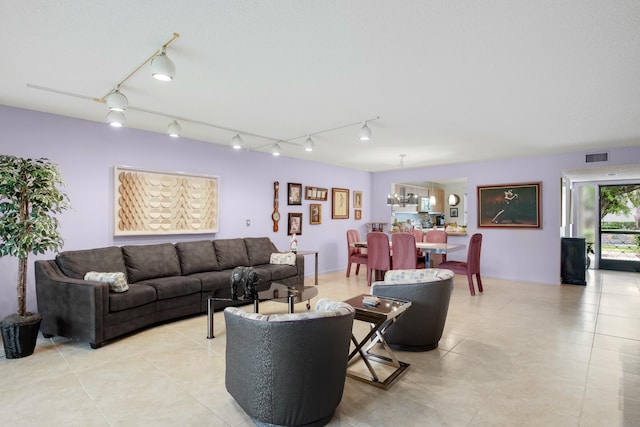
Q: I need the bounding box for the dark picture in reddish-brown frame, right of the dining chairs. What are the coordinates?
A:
[478,182,542,228]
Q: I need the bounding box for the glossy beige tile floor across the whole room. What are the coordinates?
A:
[0,271,640,427]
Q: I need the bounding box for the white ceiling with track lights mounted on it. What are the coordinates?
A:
[0,0,640,171]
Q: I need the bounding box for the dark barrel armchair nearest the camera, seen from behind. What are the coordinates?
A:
[224,298,355,426]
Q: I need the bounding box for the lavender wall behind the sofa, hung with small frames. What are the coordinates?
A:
[0,106,371,318]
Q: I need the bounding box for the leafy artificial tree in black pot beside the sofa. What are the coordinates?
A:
[0,155,69,359]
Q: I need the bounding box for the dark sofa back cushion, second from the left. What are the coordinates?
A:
[122,243,182,283]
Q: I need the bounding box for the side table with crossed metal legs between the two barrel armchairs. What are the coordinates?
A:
[345,294,411,390]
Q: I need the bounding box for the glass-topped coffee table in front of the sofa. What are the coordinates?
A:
[207,282,318,339]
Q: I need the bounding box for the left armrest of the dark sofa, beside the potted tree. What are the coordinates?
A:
[35,260,109,348]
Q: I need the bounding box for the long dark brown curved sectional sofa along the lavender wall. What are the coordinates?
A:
[35,237,304,348]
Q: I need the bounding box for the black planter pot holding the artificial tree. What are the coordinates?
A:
[2,313,42,359]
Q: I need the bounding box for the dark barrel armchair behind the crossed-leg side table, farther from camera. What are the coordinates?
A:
[371,268,454,351]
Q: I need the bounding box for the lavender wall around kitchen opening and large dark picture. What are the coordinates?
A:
[372,146,640,284]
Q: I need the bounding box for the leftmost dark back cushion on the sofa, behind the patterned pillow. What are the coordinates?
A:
[56,246,127,279]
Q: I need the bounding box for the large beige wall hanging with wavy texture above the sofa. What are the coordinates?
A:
[114,166,219,236]
